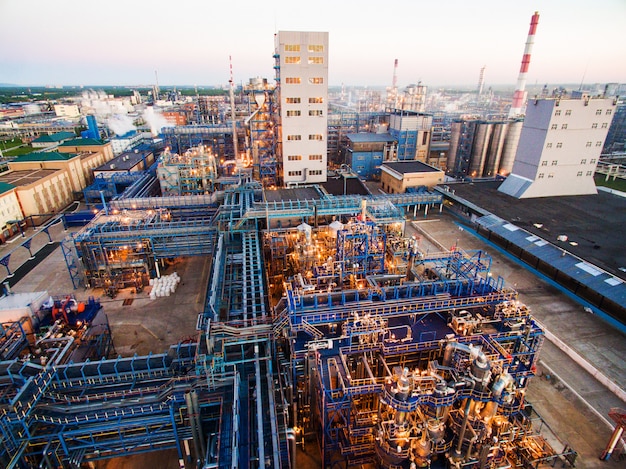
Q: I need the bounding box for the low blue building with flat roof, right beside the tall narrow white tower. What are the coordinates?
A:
[345,132,397,179]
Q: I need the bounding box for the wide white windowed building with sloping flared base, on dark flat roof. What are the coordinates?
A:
[498,95,616,199]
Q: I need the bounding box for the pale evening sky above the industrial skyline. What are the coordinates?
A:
[0,0,626,87]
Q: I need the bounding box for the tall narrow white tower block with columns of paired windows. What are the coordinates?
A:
[276,31,328,186]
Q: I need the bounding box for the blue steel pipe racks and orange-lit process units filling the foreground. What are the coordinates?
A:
[0,181,575,469]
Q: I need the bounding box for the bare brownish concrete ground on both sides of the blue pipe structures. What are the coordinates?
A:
[0,212,626,469]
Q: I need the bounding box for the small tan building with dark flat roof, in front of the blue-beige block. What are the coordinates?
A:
[380,161,445,194]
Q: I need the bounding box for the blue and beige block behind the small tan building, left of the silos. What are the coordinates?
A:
[389,110,433,162]
